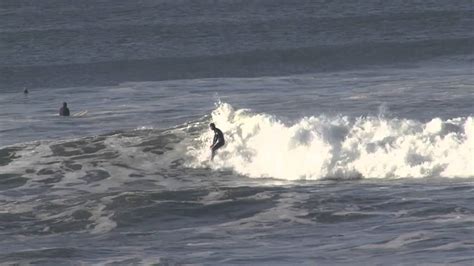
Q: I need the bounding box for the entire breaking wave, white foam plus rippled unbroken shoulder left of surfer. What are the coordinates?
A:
[0,103,474,192]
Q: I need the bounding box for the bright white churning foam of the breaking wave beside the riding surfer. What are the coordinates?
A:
[189,103,474,180]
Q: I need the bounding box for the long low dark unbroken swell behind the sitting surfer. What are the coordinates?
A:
[4,37,474,88]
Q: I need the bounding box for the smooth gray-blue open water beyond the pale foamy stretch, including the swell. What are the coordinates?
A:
[0,0,474,90]
